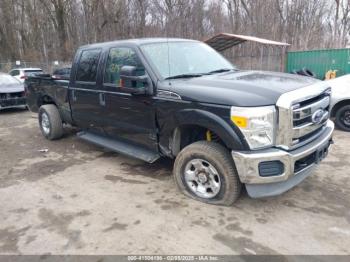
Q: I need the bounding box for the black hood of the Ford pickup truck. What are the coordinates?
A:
[162,71,319,106]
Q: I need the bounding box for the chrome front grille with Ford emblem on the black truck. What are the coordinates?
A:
[276,82,331,150]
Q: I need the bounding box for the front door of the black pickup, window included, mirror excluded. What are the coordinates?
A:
[103,47,158,151]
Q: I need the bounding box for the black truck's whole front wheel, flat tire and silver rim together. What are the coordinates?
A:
[174,141,242,206]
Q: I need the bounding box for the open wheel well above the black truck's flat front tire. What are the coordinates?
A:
[171,125,226,156]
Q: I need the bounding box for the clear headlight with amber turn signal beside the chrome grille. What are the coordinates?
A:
[231,106,276,149]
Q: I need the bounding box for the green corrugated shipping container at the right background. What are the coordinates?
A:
[286,48,350,80]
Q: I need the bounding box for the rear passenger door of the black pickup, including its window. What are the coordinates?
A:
[69,48,102,130]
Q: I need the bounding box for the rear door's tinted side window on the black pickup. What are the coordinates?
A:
[76,49,101,82]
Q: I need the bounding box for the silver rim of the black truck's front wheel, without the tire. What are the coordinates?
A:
[184,159,221,198]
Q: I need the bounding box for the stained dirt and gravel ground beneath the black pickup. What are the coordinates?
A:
[0,110,350,254]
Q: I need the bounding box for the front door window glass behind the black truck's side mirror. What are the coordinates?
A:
[104,47,145,87]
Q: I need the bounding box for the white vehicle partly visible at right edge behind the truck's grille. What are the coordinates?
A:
[327,74,350,132]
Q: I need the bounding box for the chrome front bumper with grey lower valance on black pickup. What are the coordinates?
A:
[232,120,334,197]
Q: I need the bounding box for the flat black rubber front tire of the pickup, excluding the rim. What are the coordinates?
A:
[173,141,242,206]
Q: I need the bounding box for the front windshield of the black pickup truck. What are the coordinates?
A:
[141,42,234,78]
